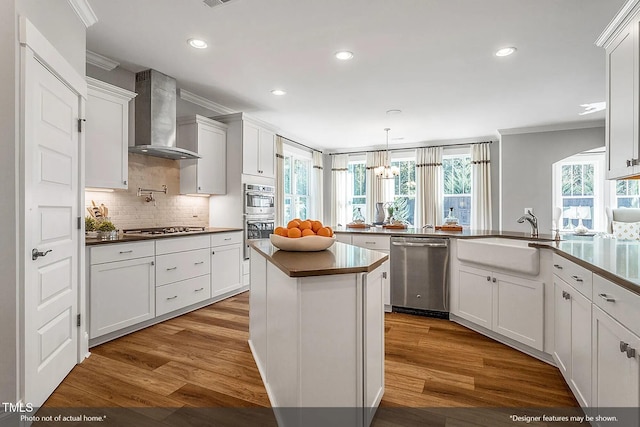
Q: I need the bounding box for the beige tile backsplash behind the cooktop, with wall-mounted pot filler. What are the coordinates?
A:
[85,154,209,230]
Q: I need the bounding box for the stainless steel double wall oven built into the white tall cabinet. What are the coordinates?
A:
[244,184,276,259]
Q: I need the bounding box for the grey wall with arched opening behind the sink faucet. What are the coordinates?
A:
[500,123,605,234]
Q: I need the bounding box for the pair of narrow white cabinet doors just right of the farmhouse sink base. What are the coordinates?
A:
[553,275,592,407]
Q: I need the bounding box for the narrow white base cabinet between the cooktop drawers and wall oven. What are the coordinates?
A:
[211,232,244,297]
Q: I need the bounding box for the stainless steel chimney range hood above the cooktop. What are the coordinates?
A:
[129,70,200,160]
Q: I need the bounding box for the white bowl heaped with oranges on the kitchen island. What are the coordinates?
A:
[269,218,336,252]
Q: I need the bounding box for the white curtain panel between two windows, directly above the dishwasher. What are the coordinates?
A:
[415,147,443,227]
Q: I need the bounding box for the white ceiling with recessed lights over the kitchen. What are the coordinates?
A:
[87,0,624,151]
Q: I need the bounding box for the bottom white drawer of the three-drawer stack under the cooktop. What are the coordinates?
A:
[156,274,211,316]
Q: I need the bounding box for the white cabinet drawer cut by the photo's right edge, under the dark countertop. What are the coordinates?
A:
[593,274,640,335]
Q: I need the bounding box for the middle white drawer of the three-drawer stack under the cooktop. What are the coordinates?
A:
[156,249,211,286]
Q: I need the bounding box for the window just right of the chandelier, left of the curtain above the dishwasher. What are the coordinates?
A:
[391,153,416,225]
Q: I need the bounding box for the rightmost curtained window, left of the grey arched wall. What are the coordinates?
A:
[442,153,471,226]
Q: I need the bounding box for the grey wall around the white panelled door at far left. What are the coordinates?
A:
[0,0,85,402]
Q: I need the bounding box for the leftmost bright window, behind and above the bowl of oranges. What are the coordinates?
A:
[284,148,312,222]
